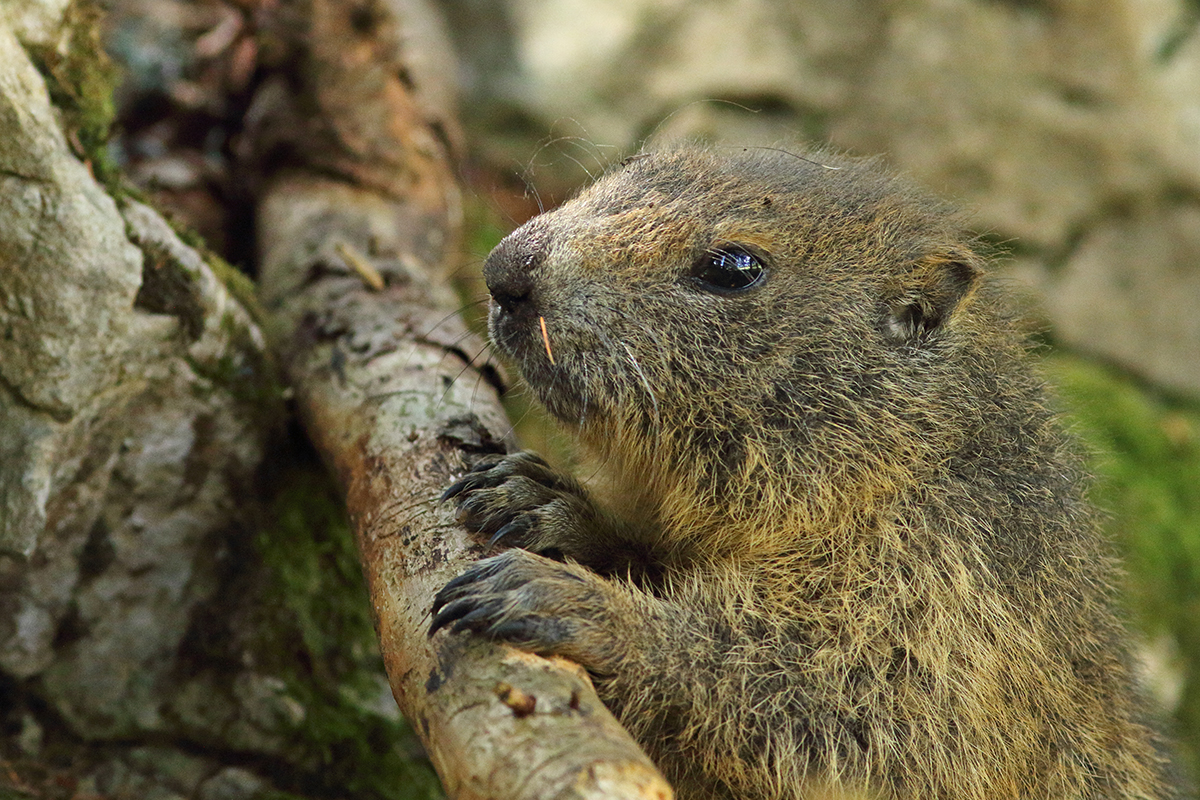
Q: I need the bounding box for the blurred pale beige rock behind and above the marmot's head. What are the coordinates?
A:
[445,0,1200,395]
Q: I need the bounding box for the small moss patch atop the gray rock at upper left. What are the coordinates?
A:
[30,0,120,190]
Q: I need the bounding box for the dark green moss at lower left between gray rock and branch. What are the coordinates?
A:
[256,467,440,800]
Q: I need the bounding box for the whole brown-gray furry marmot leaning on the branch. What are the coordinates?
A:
[431,148,1178,800]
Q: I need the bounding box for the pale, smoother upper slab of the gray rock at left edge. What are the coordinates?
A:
[0,26,160,557]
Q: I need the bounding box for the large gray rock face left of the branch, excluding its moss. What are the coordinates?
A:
[0,24,271,739]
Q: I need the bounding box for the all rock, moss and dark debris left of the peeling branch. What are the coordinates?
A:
[0,0,449,800]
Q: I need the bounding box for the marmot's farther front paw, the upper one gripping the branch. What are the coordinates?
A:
[442,451,594,558]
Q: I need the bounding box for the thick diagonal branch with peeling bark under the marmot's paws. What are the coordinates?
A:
[256,0,672,799]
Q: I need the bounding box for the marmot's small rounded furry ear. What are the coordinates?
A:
[881,253,980,344]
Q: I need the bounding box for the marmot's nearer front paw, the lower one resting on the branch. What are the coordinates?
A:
[430,549,622,674]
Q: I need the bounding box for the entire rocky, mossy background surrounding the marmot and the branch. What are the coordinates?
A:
[0,0,1200,800]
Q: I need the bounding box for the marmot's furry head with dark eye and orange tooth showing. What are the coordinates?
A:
[484,149,1013,542]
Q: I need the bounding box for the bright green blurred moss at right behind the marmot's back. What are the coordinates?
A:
[1050,356,1200,764]
